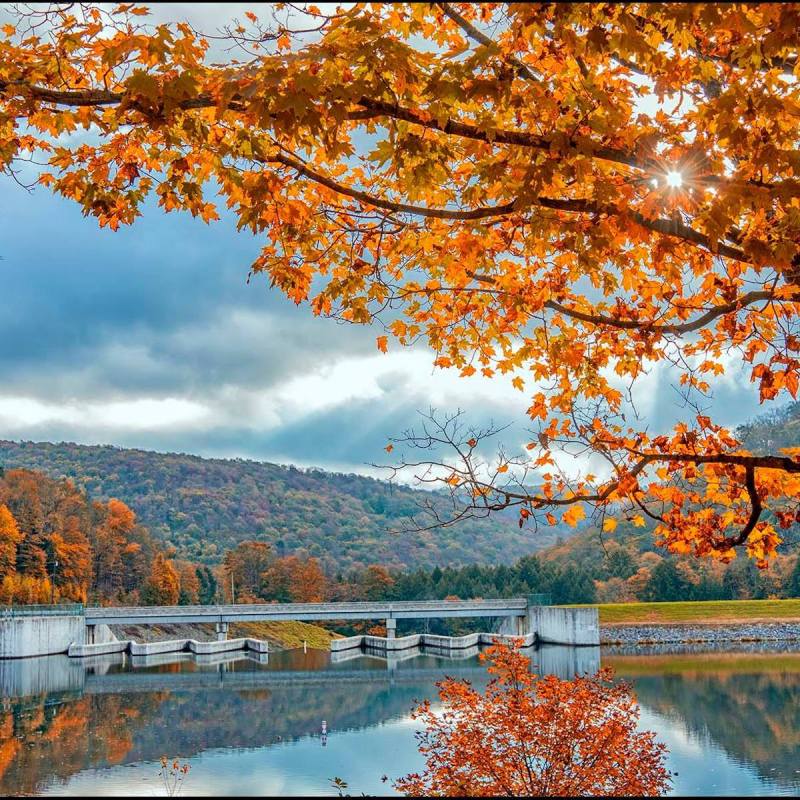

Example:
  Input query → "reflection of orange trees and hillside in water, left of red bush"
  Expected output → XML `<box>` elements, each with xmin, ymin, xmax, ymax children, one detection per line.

<box><xmin>0</xmin><ymin>654</ymin><xmax>494</xmax><ymax>794</ymax></box>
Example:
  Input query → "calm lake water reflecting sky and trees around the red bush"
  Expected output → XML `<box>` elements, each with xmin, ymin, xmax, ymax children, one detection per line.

<box><xmin>0</xmin><ymin>647</ymin><xmax>800</xmax><ymax>796</ymax></box>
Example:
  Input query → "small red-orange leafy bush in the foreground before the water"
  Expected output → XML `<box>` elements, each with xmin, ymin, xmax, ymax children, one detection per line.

<box><xmin>396</xmin><ymin>645</ymin><xmax>670</xmax><ymax>797</ymax></box>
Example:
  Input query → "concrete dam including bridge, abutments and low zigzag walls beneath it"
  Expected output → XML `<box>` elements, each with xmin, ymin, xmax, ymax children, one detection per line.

<box><xmin>0</xmin><ymin>598</ymin><xmax>600</xmax><ymax>659</ymax></box>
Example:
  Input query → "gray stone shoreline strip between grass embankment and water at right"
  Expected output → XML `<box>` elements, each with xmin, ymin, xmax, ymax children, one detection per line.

<box><xmin>600</xmin><ymin>622</ymin><xmax>800</xmax><ymax>645</ymax></box>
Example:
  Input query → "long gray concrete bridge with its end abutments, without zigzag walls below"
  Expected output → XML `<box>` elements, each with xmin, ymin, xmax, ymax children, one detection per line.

<box><xmin>0</xmin><ymin>598</ymin><xmax>600</xmax><ymax>659</ymax></box>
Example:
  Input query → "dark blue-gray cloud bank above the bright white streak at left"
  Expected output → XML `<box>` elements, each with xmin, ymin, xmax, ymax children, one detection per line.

<box><xmin>0</xmin><ymin>182</ymin><xmax>374</xmax><ymax>400</ymax></box>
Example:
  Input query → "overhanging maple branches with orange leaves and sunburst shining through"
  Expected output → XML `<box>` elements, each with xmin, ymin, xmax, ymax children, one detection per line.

<box><xmin>0</xmin><ymin>3</ymin><xmax>800</xmax><ymax>566</ymax></box>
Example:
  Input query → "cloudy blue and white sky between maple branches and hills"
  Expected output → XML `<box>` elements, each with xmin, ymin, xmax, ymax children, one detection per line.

<box><xmin>0</xmin><ymin>4</ymin><xmax>759</xmax><ymax>474</ymax></box>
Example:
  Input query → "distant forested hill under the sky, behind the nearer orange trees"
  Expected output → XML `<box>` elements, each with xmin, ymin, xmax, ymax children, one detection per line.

<box><xmin>0</xmin><ymin>440</ymin><xmax>556</xmax><ymax>575</ymax></box>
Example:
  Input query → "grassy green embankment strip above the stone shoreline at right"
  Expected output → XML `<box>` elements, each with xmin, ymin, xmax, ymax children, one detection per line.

<box><xmin>598</xmin><ymin>599</ymin><xmax>800</xmax><ymax>625</ymax></box>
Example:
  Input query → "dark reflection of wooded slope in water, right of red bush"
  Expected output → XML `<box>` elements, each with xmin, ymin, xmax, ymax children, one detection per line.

<box><xmin>613</xmin><ymin>657</ymin><xmax>800</xmax><ymax>789</ymax></box>
